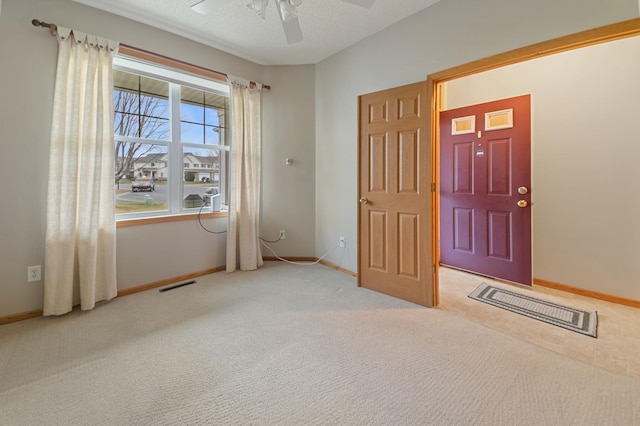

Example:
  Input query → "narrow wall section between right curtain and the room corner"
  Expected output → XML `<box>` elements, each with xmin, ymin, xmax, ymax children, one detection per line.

<box><xmin>262</xmin><ymin>65</ymin><xmax>315</xmax><ymax>256</ymax></box>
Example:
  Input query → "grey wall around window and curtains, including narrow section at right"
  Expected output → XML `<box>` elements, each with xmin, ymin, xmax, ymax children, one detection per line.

<box><xmin>0</xmin><ymin>0</ymin><xmax>315</xmax><ymax>317</ymax></box>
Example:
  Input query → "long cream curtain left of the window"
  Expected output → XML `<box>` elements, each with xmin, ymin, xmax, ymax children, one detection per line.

<box><xmin>44</xmin><ymin>27</ymin><xmax>118</xmax><ymax>315</ymax></box>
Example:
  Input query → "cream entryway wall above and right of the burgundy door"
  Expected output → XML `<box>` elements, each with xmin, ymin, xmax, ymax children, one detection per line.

<box><xmin>445</xmin><ymin>37</ymin><xmax>640</xmax><ymax>300</ymax></box>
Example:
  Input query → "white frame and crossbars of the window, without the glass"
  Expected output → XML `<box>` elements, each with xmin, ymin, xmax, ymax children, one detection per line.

<box><xmin>113</xmin><ymin>55</ymin><xmax>231</xmax><ymax>221</ymax></box>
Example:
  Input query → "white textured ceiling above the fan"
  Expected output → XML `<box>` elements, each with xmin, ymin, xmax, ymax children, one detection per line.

<box><xmin>74</xmin><ymin>0</ymin><xmax>439</xmax><ymax>65</ymax></box>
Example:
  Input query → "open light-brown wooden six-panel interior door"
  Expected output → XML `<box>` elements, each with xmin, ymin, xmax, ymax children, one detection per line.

<box><xmin>358</xmin><ymin>82</ymin><xmax>435</xmax><ymax>306</ymax></box>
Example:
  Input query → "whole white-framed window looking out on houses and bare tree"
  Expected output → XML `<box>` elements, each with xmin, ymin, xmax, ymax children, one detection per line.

<box><xmin>114</xmin><ymin>56</ymin><xmax>230</xmax><ymax>219</ymax></box>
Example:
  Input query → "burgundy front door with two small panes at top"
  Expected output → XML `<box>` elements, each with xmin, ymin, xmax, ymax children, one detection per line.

<box><xmin>440</xmin><ymin>95</ymin><xmax>532</xmax><ymax>285</ymax></box>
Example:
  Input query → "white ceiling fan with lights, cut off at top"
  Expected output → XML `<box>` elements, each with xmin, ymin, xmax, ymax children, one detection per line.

<box><xmin>191</xmin><ymin>0</ymin><xmax>376</xmax><ymax>44</ymax></box>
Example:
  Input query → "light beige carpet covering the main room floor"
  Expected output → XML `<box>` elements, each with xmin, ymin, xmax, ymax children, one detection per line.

<box><xmin>0</xmin><ymin>262</ymin><xmax>640</xmax><ymax>425</ymax></box>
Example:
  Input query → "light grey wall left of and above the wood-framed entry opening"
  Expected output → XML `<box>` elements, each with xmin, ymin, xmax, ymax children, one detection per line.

<box><xmin>316</xmin><ymin>0</ymin><xmax>638</xmax><ymax>278</ymax></box>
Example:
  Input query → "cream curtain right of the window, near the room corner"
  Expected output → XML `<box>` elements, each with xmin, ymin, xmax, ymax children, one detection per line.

<box><xmin>227</xmin><ymin>76</ymin><xmax>263</xmax><ymax>272</ymax></box>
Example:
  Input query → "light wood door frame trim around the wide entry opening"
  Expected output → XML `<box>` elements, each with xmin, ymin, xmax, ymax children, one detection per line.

<box><xmin>426</xmin><ymin>18</ymin><xmax>640</xmax><ymax>306</ymax></box>
